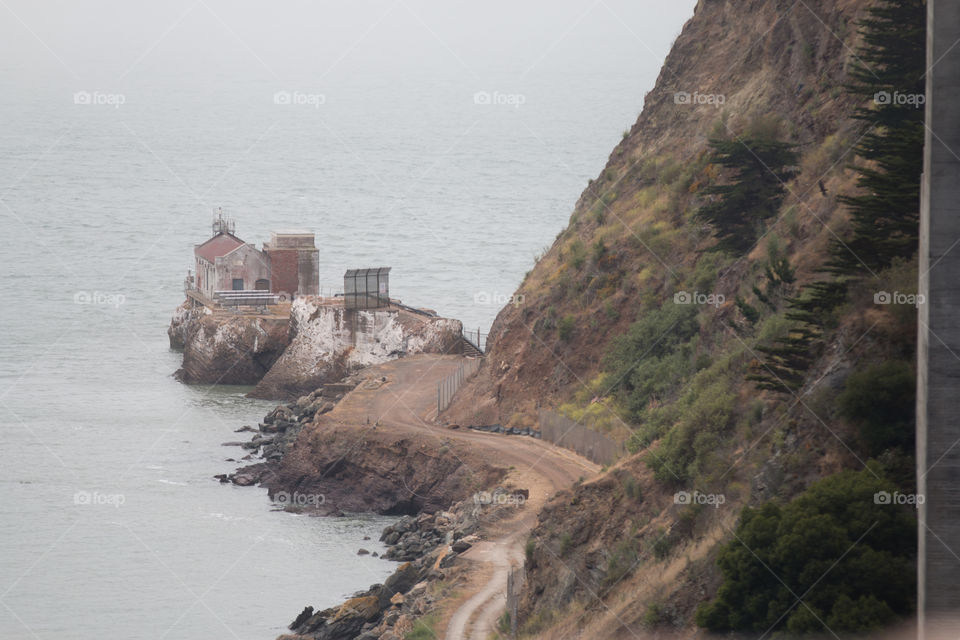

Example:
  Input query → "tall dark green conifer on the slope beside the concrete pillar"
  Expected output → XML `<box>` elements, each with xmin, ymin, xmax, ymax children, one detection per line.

<box><xmin>751</xmin><ymin>0</ymin><xmax>926</xmax><ymax>396</ymax></box>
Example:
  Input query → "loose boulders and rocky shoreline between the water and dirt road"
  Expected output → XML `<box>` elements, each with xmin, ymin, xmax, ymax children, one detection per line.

<box><xmin>215</xmin><ymin>372</ymin><xmax>528</xmax><ymax>640</ymax></box>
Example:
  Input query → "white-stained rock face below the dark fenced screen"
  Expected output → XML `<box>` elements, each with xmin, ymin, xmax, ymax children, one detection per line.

<box><xmin>250</xmin><ymin>298</ymin><xmax>461</xmax><ymax>399</ymax></box>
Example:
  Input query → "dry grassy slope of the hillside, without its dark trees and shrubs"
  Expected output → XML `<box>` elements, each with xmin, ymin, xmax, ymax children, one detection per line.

<box><xmin>451</xmin><ymin>0</ymin><xmax>915</xmax><ymax>637</ymax></box>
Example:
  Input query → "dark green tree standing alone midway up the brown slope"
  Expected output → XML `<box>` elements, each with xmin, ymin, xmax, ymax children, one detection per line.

<box><xmin>694</xmin><ymin>138</ymin><xmax>798</xmax><ymax>255</ymax></box>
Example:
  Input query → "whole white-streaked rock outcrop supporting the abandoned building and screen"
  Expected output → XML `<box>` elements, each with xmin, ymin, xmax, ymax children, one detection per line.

<box><xmin>167</xmin><ymin>298</ymin><xmax>462</xmax><ymax>400</ymax></box>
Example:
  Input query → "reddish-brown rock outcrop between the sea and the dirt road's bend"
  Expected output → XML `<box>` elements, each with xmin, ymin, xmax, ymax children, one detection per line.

<box><xmin>217</xmin><ymin>372</ymin><xmax>507</xmax><ymax>512</ymax></box>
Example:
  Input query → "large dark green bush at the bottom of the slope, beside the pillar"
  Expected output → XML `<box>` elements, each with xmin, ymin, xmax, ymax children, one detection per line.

<box><xmin>696</xmin><ymin>465</ymin><xmax>916</xmax><ymax>634</ymax></box>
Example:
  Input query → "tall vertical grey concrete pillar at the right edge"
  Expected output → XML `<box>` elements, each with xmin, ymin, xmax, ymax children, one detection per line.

<box><xmin>917</xmin><ymin>0</ymin><xmax>960</xmax><ymax>640</ymax></box>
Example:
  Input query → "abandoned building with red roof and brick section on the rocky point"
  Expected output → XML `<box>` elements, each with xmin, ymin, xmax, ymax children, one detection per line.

<box><xmin>186</xmin><ymin>211</ymin><xmax>320</xmax><ymax>301</ymax></box>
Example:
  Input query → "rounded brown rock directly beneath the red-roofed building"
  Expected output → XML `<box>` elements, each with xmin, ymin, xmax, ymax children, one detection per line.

<box><xmin>167</xmin><ymin>300</ymin><xmax>289</xmax><ymax>385</ymax></box>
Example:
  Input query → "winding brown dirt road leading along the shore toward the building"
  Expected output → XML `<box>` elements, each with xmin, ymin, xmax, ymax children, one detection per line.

<box><xmin>328</xmin><ymin>355</ymin><xmax>599</xmax><ymax>640</ymax></box>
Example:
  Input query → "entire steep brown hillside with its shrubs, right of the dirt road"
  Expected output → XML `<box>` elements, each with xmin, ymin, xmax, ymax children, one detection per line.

<box><xmin>447</xmin><ymin>0</ymin><xmax>916</xmax><ymax>638</ymax></box>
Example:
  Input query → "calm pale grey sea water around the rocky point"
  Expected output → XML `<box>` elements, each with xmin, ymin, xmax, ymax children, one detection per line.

<box><xmin>0</xmin><ymin>2</ymin><xmax>692</xmax><ymax>640</ymax></box>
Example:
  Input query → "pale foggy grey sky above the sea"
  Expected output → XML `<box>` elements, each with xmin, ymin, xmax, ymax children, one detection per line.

<box><xmin>0</xmin><ymin>0</ymin><xmax>695</xmax><ymax>89</ymax></box>
